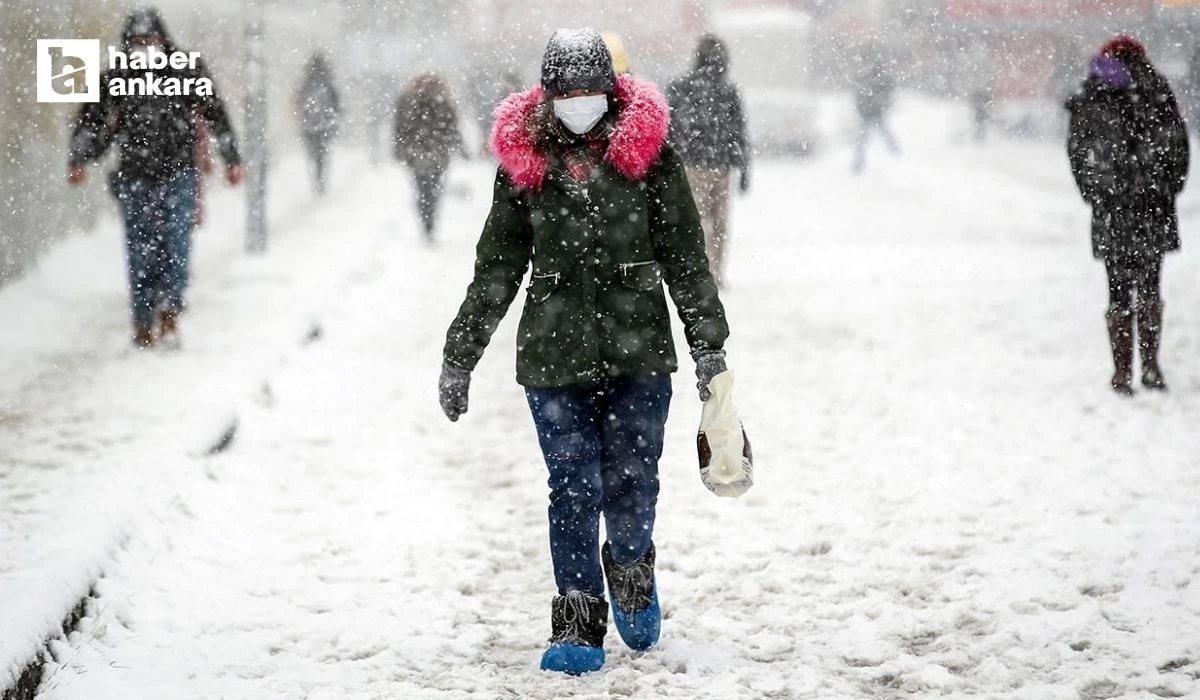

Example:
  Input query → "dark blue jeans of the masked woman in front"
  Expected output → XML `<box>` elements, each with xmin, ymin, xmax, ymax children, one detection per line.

<box><xmin>526</xmin><ymin>375</ymin><xmax>671</xmax><ymax>596</ymax></box>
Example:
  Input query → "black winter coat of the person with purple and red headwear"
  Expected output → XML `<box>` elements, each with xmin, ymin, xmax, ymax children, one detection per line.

<box><xmin>1067</xmin><ymin>59</ymin><xmax>1189</xmax><ymax>258</ymax></box>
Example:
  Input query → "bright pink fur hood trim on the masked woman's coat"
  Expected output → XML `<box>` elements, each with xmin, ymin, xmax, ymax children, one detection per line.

<box><xmin>491</xmin><ymin>76</ymin><xmax>671</xmax><ymax>190</ymax></box>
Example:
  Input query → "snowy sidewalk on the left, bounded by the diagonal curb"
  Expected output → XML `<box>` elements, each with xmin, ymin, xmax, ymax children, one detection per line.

<box><xmin>0</xmin><ymin>147</ymin><xmax>451</xmax><ymax>688</ymax></box>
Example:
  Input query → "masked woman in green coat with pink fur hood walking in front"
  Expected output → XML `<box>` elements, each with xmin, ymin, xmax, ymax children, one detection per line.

<box><xmin>439</xmin><ymin>30</ymin><xmax>728</xmax><ymax>674</ymax></box>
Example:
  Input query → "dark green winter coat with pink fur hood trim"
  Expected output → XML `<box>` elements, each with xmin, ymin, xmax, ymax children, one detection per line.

<box><xmin>444</xmin><ymin>76</ymin><xmax>728</xmax><ymax>388</ymax></box>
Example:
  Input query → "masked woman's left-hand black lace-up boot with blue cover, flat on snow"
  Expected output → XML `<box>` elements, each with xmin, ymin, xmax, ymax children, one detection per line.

<box><xmin>541</xmin><ymin>591</ymin><xmax>608</xmax><ymax>676</ymax></box>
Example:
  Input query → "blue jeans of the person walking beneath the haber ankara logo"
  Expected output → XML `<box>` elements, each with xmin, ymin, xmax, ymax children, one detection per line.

<box><xmin>115</xmin><ymin>169</ymin><xmax>199</xmax><ymax>324</ymax></box>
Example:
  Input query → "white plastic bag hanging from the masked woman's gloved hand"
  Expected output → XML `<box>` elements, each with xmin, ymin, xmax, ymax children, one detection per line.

<box><xmin>696</xmin><ymin>371</ymin><xmax>754</xmax><ymax>498</ymax></box>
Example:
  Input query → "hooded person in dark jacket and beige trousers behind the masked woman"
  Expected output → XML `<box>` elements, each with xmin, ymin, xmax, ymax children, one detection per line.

<box><xmin>667</xmin><ymin>34</ymin><xmax>750</xmax><ymax>286</ymax></box>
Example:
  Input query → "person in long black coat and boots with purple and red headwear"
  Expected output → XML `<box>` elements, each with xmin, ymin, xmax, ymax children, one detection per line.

<box><xmin>1067</xmin><ymin>36</ymin><xmax>1189</xmax><ymax>395</ymax></box>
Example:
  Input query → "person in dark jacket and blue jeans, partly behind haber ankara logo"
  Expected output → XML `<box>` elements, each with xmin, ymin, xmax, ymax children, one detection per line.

<box><xmin>67</xmin><ymin>10</ymin><xmax>242</xmax><ymax>348</ymax></box>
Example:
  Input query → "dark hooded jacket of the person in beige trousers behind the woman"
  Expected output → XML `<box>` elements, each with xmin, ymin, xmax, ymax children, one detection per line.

<box><xmin>667</xmin><ymin>37</ymin><xmax>750</xmax><ymax>169</ymax></box>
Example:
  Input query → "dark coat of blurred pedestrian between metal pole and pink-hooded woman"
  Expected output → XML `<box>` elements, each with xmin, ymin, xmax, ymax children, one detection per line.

<box><xmin>392</xmin><ymin>74</ymin><xmax>462</xmax><ymax>172</ymax></box>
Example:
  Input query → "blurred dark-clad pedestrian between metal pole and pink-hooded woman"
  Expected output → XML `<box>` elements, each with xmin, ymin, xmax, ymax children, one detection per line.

<box><xmin>392</xmin><ymin>73</ymin><xmax>466</xmax><ymax>241</ymax></box>
